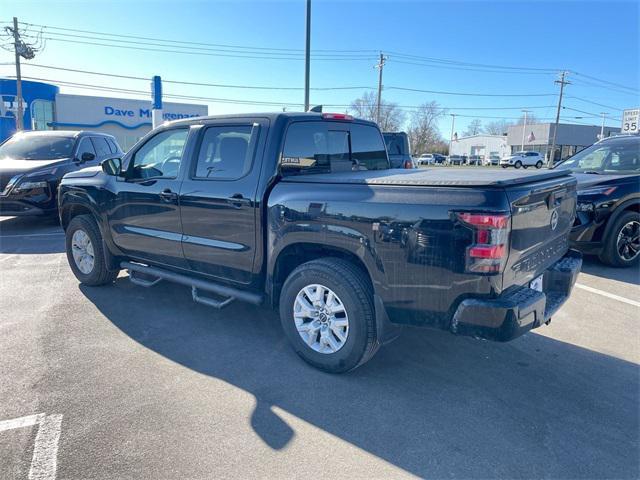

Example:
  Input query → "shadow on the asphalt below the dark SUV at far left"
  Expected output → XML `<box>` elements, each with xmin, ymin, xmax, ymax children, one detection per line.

<box><xmin>0</xmin><ymin>217</ymin><xmax>65</xmax><ymax>254</ymax></box>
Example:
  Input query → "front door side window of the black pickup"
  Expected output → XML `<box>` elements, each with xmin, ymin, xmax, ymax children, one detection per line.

<box><xmin>129</xmin><ymin>128</ymin><xmax>189</xmax><ymax>179</ymax></box>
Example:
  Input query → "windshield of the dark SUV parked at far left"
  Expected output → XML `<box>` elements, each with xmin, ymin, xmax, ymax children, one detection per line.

<box><xmin>0</xmin><ymin>135</ymin><xmax>75</xmax><ymax>160</ymax></box>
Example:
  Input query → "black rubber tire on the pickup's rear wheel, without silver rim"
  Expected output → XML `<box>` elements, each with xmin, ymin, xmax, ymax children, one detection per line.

<box><xmin>280</xmin><ymin>258</ymin><xmax>380</xmax><ymax>373</ymax></box>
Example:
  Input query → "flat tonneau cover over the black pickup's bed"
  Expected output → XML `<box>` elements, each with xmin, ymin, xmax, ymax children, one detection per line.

<box><xmin>282</xmin><ymin>167</ymin><xmax>571</xmax><ymax>187</ymax></box>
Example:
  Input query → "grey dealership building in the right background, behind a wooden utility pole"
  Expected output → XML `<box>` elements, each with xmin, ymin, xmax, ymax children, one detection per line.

<box><xmin>507</xmin><ymin>123</ymin><xmax>620</xmax><ymax>162</ymax></box>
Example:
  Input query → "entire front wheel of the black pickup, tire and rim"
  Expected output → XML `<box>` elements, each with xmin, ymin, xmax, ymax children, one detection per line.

<box><xmin>65</xmin><ymin>215</ymin><xmax>118</xmax><ymax>286</ymax></box>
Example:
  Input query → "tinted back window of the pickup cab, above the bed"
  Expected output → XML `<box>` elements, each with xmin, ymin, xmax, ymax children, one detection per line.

<box><xmin>280</xmin><ymin>122</ymin><xmax>389</xmax><ymax>175</ymax></box>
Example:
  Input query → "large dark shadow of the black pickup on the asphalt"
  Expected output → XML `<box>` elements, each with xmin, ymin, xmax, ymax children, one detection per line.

<box><xmin>80</xmin><ymin>277</ymin><xmax>640</xmax><ymax>478</ymax></box>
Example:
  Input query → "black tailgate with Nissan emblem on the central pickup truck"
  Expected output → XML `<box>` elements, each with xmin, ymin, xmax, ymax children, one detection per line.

<box><xmin>503</xmin><ymin>172</ymin><xmax>576</xmax><ymax>288</ymax></box>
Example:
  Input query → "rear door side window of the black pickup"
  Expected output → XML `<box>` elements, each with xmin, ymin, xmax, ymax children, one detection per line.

<box><xmin>194</xmin><ymin>125</ymin><xmax>259</xmax><ymax>180</ymax></box>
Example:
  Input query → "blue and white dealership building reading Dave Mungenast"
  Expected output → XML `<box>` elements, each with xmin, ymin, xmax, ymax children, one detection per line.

<box><xmin>0</xmin><ymin>78</ymin><xmax>208</xmax><ymax>151</ymax></box>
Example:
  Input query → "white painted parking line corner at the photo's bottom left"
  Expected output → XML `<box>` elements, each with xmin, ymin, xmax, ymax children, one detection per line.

<box><xmin>0</xmin><ymin>413</ymin><xmax>62</xmax><ymax>480</ymax></box>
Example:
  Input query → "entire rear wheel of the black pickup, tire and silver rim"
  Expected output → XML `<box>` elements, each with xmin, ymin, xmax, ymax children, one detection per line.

<box><xmin>280</xmin><ymin>258</ymin><xmax>379</xmax><ymax>373</ymax></box>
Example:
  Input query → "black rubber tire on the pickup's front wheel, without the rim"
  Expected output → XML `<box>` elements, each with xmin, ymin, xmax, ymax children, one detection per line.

<box><xmin>65</xmin><ymin>215</ymin><xmax>119</xmax><ymax>286</ymax></box>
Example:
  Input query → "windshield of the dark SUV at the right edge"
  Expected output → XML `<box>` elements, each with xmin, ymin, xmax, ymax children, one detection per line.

<box><xmin>556</xmin><ymin>137</ymin><xmax>640</xmax><ymax>174</ymax></box>
